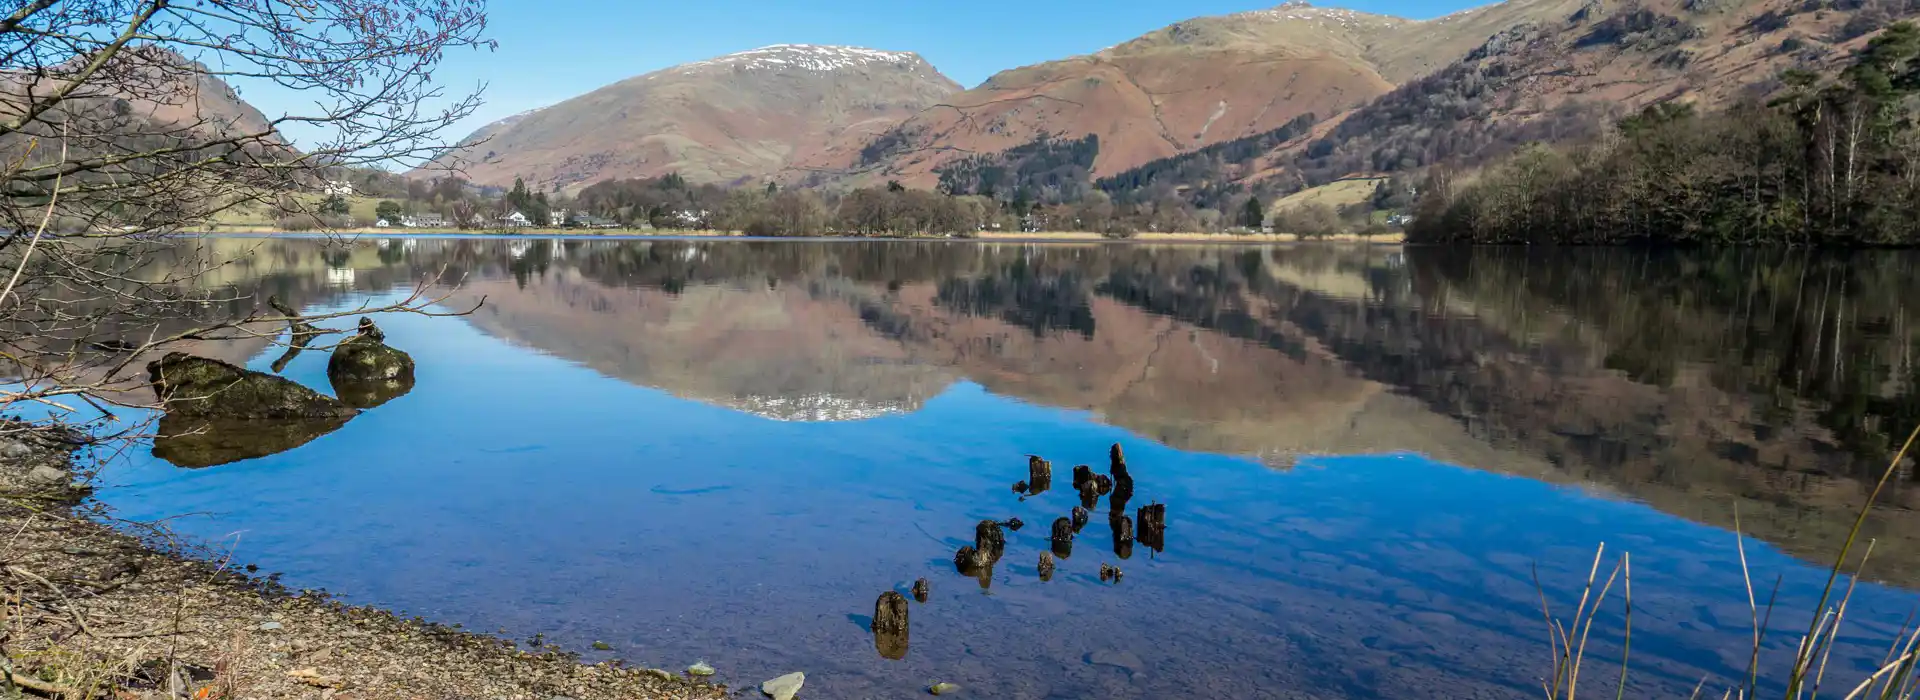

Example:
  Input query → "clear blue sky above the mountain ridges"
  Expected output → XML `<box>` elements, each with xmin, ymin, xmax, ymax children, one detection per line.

<box><xmin>242</xmin><ymin>0</ymin><xmax>1488</xmax><ymax>152</ymax></box>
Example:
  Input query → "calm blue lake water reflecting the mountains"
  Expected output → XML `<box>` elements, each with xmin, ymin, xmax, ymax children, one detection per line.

<box><xmin>100</xmin><ymin>238</ymin><xmax>1920</xmax><ymax>698</ymax></box>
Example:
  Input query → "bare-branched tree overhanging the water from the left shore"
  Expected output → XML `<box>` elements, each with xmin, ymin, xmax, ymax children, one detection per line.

<box><xmin>0</xmin><ymin>0</ymin><xmax>490</xmax><ymax>450</ymax></box>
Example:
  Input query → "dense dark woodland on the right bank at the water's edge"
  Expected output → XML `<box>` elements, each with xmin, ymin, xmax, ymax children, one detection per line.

<box><xmin>1407</xmin><ymin>21</ymin><xmax>1920</xmax><ymax>245</ymax></box>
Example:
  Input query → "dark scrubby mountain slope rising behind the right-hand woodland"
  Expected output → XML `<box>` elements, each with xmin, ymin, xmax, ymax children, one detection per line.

<box><xmin>1175</xmin><ymin>0</ymin><xmax>1916</xmax><ymax>188</ymax></box>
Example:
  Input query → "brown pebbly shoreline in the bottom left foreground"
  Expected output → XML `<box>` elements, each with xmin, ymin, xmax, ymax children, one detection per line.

<box><xmin>0</xmin><ymin>422</ymin><xmax>728</xmax><ymax>700</ymax></box>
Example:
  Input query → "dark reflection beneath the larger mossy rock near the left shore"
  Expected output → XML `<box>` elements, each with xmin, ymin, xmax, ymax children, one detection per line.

<box><xmin>154</xmin><ymin>412</ymin><xmax>348</xmax><ymax>470</ymax></box>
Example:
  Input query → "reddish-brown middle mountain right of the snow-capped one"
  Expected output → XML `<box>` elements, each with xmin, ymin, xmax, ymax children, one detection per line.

<box><xmin>847</xmin><ymin>0</ymin><xmax>1605</xmax><ymax>186</ymax></box>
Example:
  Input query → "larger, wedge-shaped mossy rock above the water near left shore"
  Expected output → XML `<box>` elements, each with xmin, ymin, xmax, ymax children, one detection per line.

<box><xmin>146</xmin><ymin>353</ymin><xmax>359</xmax><ymax>420</ymax></box>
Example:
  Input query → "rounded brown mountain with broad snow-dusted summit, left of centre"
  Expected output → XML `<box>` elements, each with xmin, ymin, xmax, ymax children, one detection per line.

<box><xmin>420</xmin><ymin>44</ymin><xmax>960</xmax><ymax>188</ymax></box>
